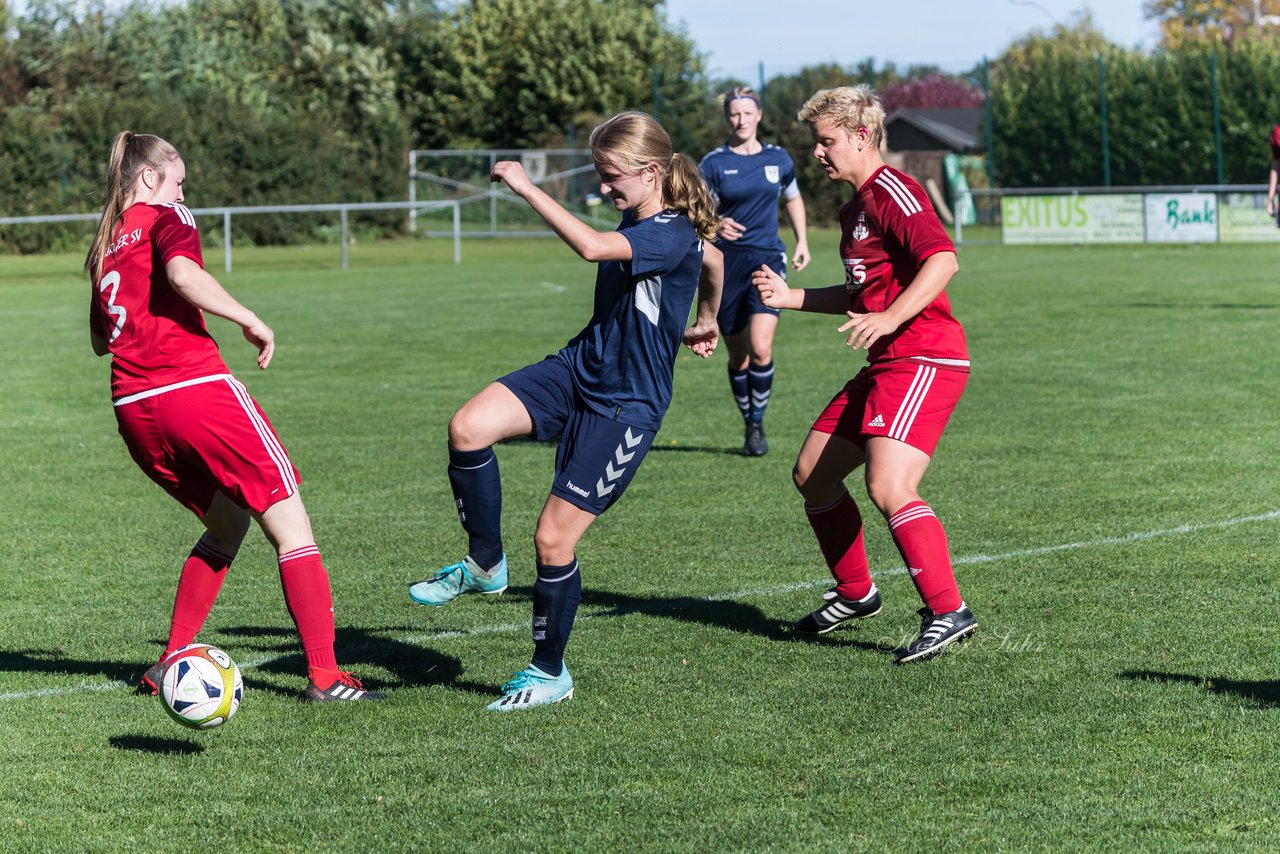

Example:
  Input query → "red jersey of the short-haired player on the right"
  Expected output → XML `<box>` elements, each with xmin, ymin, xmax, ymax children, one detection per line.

<box><xmin>840</xmin><ymin>166</ymin><xmax>969</xmax><ymax>370</ymax></box>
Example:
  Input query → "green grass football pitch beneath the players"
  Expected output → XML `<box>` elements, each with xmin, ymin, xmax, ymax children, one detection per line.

<box><xmin>0</xmin><ymin>233</ymin><xmax>1280</xmax><ymax>851</ymax></box>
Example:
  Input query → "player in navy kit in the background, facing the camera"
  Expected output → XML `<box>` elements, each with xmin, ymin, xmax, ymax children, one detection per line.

<box><xmin>698</xmin><ymin>86</ymin><xmax>809</xmax><ymax>457</ymax></box>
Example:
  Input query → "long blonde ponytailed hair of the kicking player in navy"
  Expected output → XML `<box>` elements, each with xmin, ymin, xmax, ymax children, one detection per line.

<box><xmin>591</xmin><ymin>111</ymin><xmax>719</xmax><ymax>241</ymax></box>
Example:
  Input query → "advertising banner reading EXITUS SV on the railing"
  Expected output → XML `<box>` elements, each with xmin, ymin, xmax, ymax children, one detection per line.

<box><xmin>1000</xmin><ymin>193</ymin><xmax>1144</xmax><ymax>243</ymax></box>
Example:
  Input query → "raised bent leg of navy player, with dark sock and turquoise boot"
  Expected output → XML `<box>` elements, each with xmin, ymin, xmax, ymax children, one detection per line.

<box><xmin>408</xmin><ymin>383</ymin><xmax>534</xmax><ymax>606</ymax></box>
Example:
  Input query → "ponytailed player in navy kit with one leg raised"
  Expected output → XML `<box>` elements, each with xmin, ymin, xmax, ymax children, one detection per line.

<box><xmin>410</xmin><ymin>113</ymin><xmax>723</xmax><ymax>712</ymax></box>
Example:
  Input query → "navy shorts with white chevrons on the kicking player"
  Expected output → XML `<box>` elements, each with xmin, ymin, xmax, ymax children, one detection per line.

<box><xmin>498</xmin><ymin>356</ymin><xmax>654</xmax><ymax>516</ymax></box>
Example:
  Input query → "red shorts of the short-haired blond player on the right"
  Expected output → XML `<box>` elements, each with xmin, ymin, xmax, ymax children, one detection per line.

<box><xmin>813</xmin><ymin>359</ymin><xmax>969</xmax><ymax>457</ymax></box>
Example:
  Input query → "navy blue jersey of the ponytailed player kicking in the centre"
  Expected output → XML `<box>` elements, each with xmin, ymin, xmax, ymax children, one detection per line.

<box><xmin>561</xmin><ymin>210</ymin><xmax>703</xmax><ymax>430</ymax></box>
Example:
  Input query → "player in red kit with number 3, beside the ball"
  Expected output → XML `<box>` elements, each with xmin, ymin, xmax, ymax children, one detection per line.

<box><xmin>84</xmin><ymin>131</ymin><xmax>384</xmax><ymax>703</ymax></box>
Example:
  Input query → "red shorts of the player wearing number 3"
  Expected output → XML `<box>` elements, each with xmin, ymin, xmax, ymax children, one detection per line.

<box><xmin>115</xmin><ymin>374</ymin><xmax>302</xmax><ymax>516</ymax></box>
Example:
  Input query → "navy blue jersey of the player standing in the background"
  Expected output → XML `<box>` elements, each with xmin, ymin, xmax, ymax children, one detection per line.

<box><xmin>698</xmin><ymin>143</ymin><xmax>800</xmax><ymax>252</ymax></box>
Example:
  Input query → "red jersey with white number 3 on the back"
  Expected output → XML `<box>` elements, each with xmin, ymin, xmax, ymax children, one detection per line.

<box><xmin>91</xmin><ymin>204</ymin><xmax>229</xmax><ymax>398</ymax></box>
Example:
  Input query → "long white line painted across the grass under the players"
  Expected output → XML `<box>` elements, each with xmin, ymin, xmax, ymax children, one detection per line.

<box><xmin>0</xmin><ymin>510</ymin><xmax>1280</xmax><ymax>702</ymax></box>
